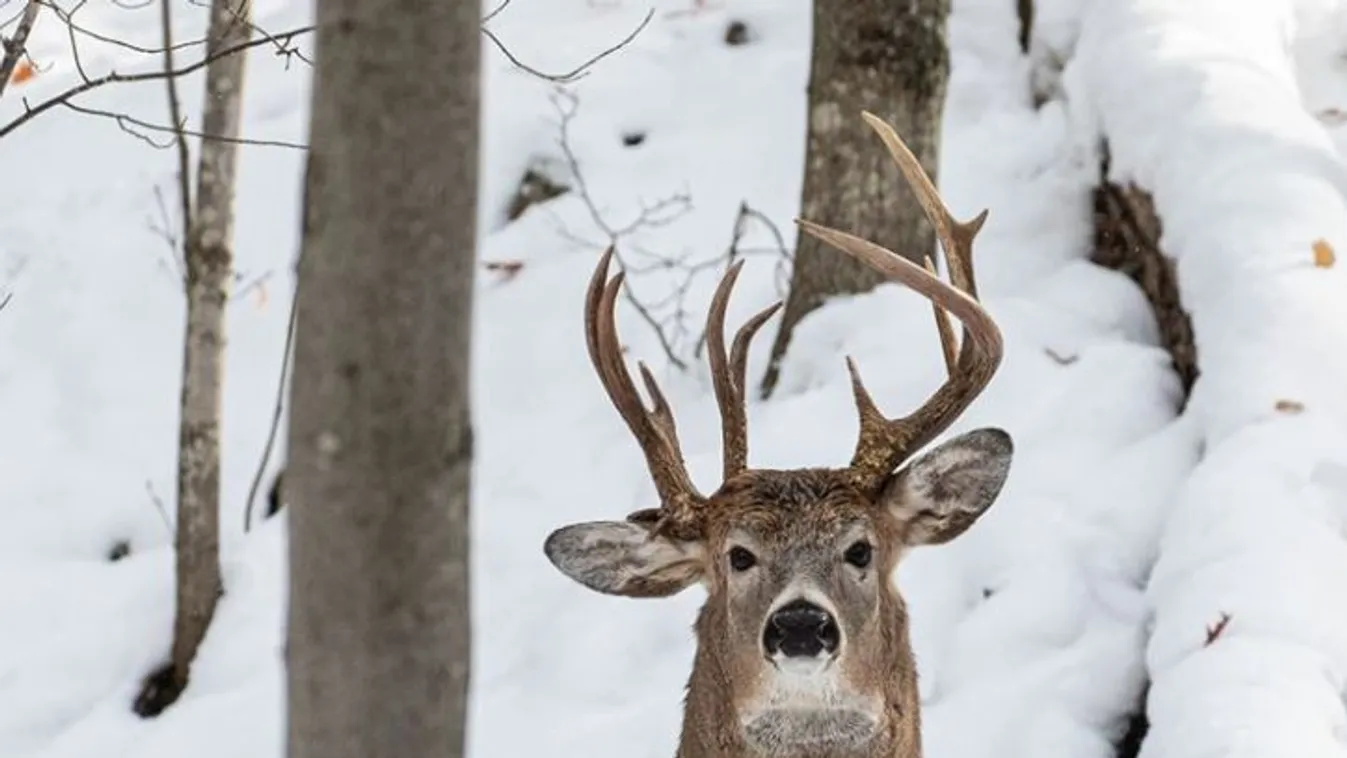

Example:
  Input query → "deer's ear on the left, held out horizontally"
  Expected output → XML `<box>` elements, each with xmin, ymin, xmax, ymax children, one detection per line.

<box><xmin>543</xmin><ymin>521</ymin><xmax>706</xmax><ymax>598</ymax></box>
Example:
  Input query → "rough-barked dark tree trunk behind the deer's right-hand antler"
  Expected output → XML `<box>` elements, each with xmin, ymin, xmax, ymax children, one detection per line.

<box><xmin>762</xmin><ymin>0</ymin><xmax>950</xmax><ymax>397</ymax></box>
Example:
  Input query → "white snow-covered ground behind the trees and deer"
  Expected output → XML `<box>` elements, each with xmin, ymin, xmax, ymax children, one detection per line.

<box><xmin>0</xmin><ymin>0</ymin><xmax>1347</xmax><ymax>758</ymax></box>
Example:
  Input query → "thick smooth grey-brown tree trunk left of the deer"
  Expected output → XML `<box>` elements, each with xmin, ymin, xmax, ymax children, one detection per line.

<box><xmin>286</xmin><ymin>0</ymin><xmax>480</xmax><ymax>758</ymax></box>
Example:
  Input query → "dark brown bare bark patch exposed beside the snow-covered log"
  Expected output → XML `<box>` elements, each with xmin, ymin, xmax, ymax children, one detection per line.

<box><xmin>1091</xmin><ymin>146</ymin><xmax>1197</xmax><ymax>399</ymax></box>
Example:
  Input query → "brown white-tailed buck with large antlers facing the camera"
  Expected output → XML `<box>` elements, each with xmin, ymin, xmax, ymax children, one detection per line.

<box><xmin>544</xmin><ymin>113</ymin><xmax>1012</xmax><ymax>758</ymax></box>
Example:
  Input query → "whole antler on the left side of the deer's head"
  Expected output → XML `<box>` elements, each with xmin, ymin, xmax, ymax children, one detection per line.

<box><xmin>585</xmin><ymin>246</ymin><xmax>781</xmax><ymax>537</ymax></box>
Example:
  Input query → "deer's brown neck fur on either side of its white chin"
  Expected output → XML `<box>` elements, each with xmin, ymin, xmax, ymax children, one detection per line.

<box><xmin>675</xmin><ymin>600</ymin><xmax>921</xmax><ymax>758</ymax></box>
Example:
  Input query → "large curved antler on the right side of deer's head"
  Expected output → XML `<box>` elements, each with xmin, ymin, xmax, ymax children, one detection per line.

<box><xmin>796</xmin><ymin>113</ymin><xmax>1002</xmax><ymax>494</ymax></box>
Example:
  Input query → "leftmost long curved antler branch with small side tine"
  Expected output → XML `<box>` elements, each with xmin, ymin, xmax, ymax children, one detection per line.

<box><xmin>585</xmin><ymin>246</ymin><xmax>703</xmax><ymax>522</ymax></box>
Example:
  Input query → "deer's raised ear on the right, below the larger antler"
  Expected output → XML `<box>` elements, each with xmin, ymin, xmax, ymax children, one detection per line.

<box><xmin>880</xmin><ymin>428</ymin><xmax>1014</xmax><ymax>547</ymax></box>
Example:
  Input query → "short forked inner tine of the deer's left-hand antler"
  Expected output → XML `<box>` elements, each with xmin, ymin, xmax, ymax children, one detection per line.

<box><xmin>706</xmin><ymin>260</ymin><xmax>781</xmax><ymax>479</ymax></box>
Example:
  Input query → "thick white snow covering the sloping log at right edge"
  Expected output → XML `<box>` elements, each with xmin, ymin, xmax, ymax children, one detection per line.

<box><xmin>1067</xmin><ymin>0</ymin><xmax>1347</xmax><ymax>758</ymax></box>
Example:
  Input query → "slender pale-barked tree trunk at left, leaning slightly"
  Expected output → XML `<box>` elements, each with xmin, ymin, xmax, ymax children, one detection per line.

<box><xmin>172</xmin><ymin>0</ymin><xmax>252</xmax><ymax>689</ymax></box>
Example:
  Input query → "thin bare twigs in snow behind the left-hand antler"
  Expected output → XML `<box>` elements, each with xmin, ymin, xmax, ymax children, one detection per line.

<box><xmin>552</xmin><ymin>88</ymin><xmax>791</xmax><ymax>370</ymax></box>
